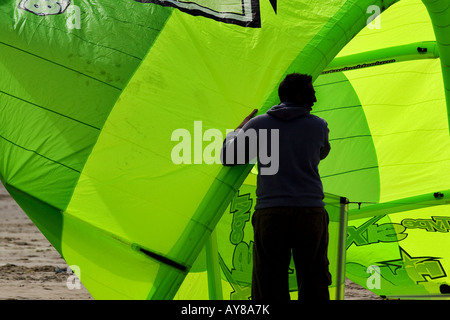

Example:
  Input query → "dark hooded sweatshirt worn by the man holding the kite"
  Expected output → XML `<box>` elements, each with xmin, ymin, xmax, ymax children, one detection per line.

<box><xmin>222</xmin><ymin>102</ymin><xmax>330</xmax><ymax>209</ymax></box>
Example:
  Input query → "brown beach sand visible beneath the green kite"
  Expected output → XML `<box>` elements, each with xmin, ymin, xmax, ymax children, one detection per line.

<box><xmin>0</xmin><ymin>183</ymin><xmax>380</xmax><ymax>300</ymax></box>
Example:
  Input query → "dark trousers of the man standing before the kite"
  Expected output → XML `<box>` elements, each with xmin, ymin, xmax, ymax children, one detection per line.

<box><xmin>252</xmin><ymin>207</ymin><xmax>331</xmax><ymax>300</ymax></box>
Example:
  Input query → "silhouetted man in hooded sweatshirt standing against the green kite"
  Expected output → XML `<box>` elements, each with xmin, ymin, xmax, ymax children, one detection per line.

<box><xmin>222</xmin><ymin>73</ymin><xmax>331</xmax><ymax>300</ymax></box>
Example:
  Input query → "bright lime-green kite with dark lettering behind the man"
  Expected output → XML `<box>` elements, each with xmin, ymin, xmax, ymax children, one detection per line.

<box><xmin>0</xmin><ymin>0</ymin><xmax>450</xmax><ymax>299</ymax></box>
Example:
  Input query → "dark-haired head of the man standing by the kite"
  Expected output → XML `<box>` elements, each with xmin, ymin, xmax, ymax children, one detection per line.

<box><xmin>278</xmin><ymin>73</ymin><xmax>317</xmax><ymax>110</ymax></box>
